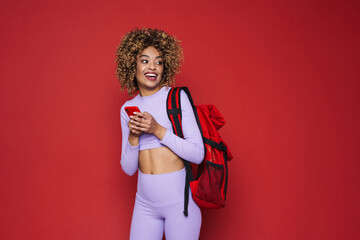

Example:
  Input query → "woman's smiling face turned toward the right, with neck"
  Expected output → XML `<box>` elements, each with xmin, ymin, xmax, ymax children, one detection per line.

<box><xmin>135</xmin><ymin>46</ymin><xmax>164</xmax><ymax>96</ymax></box>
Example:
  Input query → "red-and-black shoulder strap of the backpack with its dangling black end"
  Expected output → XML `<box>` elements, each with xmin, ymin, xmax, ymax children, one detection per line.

<box><xmin>166</xmin><ymin>87</ymin><xmax>195</xmax><ymax>216</ymax></box>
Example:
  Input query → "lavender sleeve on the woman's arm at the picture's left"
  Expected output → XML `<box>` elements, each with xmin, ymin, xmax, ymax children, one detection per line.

<box><xmin>120</xmin><ymin>106</ymin><xmax>139</xmax><ymax>176</ymax></box>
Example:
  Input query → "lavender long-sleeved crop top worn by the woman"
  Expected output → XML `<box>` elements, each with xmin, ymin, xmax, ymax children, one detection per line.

<box><xmin>120</xmin><ymin>87</ymin><xmax>204</xmax><ymax>175</ymax></box>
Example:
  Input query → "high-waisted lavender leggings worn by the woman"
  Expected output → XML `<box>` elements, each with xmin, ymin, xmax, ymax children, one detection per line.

<box><xmin>130</xmin><ymin>168</ymin><xmax>201</xmax><ymax>240</ymax></box>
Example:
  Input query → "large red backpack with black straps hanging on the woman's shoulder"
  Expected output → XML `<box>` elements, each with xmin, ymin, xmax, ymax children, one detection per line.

<box><xmin>167</xmin><ymin>87</ymin><xmax>232</xmax><ymax>216</ymax></box>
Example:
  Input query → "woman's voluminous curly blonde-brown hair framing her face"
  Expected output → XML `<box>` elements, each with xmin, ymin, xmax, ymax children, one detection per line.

<box><xmin>115</xmin><ymin>28</ymin><xmax>183</xmax><ymax>95</ymax></box>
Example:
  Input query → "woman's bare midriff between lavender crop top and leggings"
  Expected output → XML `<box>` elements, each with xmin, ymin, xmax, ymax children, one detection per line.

<box><xmin>139</xmin><ymin>147</ymin><xmax>184</xmax><ymax>174</ymax></box>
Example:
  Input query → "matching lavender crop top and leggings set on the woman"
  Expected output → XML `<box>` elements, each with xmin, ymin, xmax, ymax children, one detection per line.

<box><xmin>120</xmin><ymin>87</ymin><xmax>204</xmax><ymax>240</ymax></box>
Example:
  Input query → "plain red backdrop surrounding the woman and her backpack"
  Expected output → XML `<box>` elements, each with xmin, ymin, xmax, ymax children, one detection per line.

<box><xmin>0</xmin><ymin>0</ymin><xmax>360</xmax><ymax>240</ymax></box>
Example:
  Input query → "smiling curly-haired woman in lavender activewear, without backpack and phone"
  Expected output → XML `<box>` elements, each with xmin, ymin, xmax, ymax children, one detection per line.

<box><xmin>116</xmin><ymin>28</ymin><xmax>204</xmax><ymax>240</ymax></box>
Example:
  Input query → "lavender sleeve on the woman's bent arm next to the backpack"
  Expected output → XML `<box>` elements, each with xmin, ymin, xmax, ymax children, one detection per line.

<box><xmin>160</xmin><ymin>91</ymin><xmax>205</xmax><ymax>164</ymax></box>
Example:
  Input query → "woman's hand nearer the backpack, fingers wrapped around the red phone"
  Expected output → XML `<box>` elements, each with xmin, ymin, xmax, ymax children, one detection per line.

<box><xmin>130</xmin><ymin>112</ymin><xmax>167</xmax><ymax>140</ymax></box>
